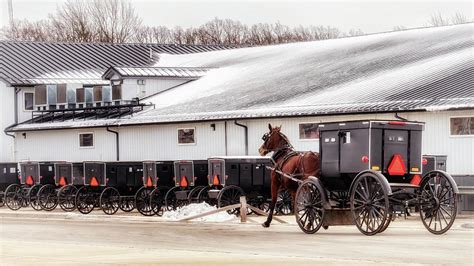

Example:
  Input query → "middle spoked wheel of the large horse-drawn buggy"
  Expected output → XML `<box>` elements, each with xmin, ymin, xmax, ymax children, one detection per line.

<box><xmin>351</xmin><ymin>173</ymin><xmax>390</xmax><ymax>236</ymax></box>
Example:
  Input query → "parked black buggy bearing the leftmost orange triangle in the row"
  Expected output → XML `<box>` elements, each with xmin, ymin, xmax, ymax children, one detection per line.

<box><xmin>5</xmin><ymin>162</ymin><xmax>54</xmax><ymax>211</ymax></box>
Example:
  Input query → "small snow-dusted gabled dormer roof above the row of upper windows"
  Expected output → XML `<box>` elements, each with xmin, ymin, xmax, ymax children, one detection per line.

<box><xmin>102</xmin><ymin>66</ymin><xmax>210</xmax><ymax>78</ymax></box>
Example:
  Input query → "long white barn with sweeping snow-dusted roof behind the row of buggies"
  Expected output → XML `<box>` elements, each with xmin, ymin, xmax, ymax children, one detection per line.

<box><xmin>0</xmin><ymin>24</ymin><xmax>474</xmax><ymax>207</ymax></box>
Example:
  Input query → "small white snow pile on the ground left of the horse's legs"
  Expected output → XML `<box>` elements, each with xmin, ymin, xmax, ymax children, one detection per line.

<box><xmin>163</xmin><ymin>202</ymin><xmax>236</xmax><ymax>222</ymax></box>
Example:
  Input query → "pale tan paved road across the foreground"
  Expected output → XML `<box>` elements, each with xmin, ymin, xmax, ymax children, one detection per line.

<box><xmin>0</xmin><ymin>209</ymin><xmax>474</xmax><ymax>265</ymax></box>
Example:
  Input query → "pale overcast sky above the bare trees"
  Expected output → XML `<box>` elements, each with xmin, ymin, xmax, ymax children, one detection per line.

<box><xmin>0</xmin><ymin>0</ymin><xmax>473</xmax><ymax>33</ymax></box>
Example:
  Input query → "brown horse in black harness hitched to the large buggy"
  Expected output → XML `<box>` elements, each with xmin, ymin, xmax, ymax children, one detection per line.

<box><xmin>258</xmin><ymin>124</ymin><xmax>320</xmax><ymax>227</ymax></box>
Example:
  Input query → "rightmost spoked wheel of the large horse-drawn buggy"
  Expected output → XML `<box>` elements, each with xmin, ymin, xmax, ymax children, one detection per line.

<box><xmin>419</xmin><ymin>171</ymin><xmax>457</xmax><ymax>235</ymax></box>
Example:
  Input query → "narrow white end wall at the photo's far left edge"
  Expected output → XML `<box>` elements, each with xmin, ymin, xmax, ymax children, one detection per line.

<box><xmin>0</xmin><ymin>80</ymin><xmax>15</xmax><ymax>162</ymax></box>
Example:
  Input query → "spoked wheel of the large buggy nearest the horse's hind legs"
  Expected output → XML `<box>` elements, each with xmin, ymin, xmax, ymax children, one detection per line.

<box><xmin>295</xmin><ymin>180</ymin><xmax>325</xmax><ymax>234</ymax></box>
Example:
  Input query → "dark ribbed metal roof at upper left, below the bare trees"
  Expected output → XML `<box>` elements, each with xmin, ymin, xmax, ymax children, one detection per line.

<box><xmin>0</xmin><ymin>41</ymin><xmax>233</xmax><ymax>85</ymax></box>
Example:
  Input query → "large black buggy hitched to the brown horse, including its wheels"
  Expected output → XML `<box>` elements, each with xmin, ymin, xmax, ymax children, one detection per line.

<box><xmin>295</xmin><ymin>121</ymin><xmax>458</xmax><ymax>235</ymax></box>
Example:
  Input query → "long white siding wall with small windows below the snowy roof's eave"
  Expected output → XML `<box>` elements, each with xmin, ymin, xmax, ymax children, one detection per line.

<box><xmin>12</xmin><ymin>110</ymin><xmax>474</xmax><ymax>175</ymax></box>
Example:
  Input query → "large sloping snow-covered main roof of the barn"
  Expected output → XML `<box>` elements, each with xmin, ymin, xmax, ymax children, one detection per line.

<box><xmin>9</xmin><ymin>23</ymin><xmax>474</xmax><ymax>130</ymax></box>
